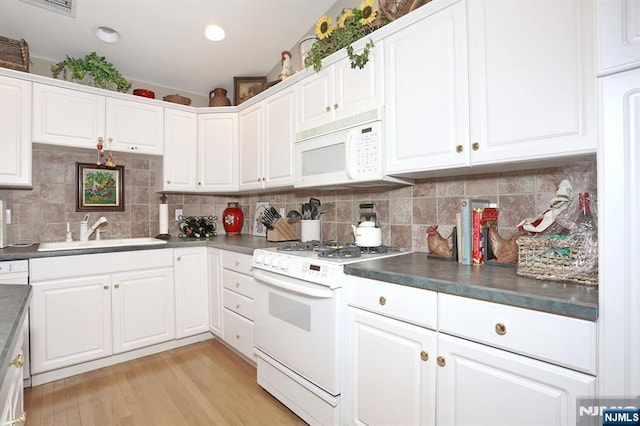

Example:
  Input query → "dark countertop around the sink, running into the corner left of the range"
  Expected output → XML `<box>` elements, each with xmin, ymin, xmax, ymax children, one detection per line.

<box><xmin>0</xmin><ymin>234</ymin><xmax>276</xmax><ymax>262</ymax></box>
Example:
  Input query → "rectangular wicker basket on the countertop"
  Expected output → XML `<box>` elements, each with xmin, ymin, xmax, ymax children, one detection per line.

<box><xmin>516</xmin><ymin>235</ymin><xmax>598</xmax><ymax>285</ymax></box>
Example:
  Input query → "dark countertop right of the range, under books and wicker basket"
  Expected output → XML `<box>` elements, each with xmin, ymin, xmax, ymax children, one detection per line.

<box><xmin>345</xmin><ymin>252</ymin><xmax>598</xmax><ymax>321</ymax></box>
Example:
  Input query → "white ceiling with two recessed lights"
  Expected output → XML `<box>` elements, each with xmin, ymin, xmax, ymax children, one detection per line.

<box><xmin>0</xmin><ymin>0</ymin><xmax>336</xmax><ymax>96</ymax></box>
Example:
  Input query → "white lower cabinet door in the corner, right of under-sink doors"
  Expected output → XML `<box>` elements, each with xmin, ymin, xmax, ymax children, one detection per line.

<box><xmin>173</xmin><ymin>247</ymin><xmax>209</xmax><ymax>339</ymax></box>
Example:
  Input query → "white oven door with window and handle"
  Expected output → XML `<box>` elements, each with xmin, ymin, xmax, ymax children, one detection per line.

<box><xmin>254</xmin><ymin>270</ymin><xmax>342</xmax><ymax>396</ymax></box>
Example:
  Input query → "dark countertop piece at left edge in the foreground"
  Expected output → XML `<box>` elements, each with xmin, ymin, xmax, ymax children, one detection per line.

<box><xmin>0</xmin><ymin>284</ymin><xmax>31</xmax><ymax>382</ymax></box>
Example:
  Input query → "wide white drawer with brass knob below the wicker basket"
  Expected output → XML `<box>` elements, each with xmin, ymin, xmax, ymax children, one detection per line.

<box><xmin>438</xmin><ymin>294</ymin><xmax>596</xmax><ymax>374</ymax></box>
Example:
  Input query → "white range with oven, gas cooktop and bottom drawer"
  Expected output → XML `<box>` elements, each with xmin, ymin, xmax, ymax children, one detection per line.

<box><xmin>252</xmin><ymin>241</ymin><xmax>410</xmax><ymax>425</ymax></box>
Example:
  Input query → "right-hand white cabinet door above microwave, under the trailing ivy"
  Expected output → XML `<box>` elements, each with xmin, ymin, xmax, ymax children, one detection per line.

<box><xmin>331</xmin><ymin>37</ymin><xmax>386</xmax><ymax>120</ymax></box>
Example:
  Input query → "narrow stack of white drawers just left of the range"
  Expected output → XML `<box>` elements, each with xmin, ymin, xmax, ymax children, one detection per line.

<box><xmin>222</xmin><ymin>250</ymin><xmax>255</xmax><ymax>362</ymax></box>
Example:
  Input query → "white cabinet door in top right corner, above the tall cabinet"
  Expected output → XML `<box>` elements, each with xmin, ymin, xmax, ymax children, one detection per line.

<box><xmin>596</xmin><ymin>0</ymin><xmax>640</xmax><ymax>75</ymax></box>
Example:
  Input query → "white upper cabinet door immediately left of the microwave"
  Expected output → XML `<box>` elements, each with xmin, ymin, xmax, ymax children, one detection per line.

<box><xmin>263</xmin><ymin>88</ymin><xmax>296</xmax><ymax>188</ymax></box>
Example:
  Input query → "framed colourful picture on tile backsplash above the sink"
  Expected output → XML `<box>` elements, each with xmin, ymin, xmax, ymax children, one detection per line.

<box><xmin>76</xmin><ymin>163</ymin><xmax>124</xmax><ymax>212</ymax></box>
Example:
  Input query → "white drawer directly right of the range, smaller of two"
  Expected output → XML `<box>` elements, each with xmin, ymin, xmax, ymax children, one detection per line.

<box><xmin>347</xmin><ymin>276</ymin><xmax>438</xmax><ymax>328</ymax></box>
